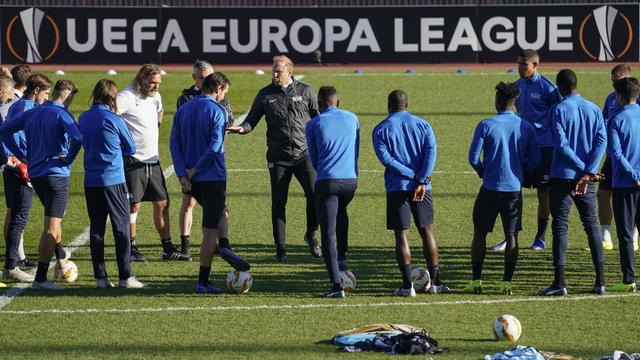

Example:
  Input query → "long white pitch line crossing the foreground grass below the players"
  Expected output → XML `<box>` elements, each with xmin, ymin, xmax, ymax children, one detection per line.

<box><xmin>2</xmin><ymin>293</ymin><xmax>640</xmax><ymax>315</ymax></box>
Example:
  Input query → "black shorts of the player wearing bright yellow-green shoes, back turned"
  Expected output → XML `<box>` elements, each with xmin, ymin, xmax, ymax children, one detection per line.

<box><xmin>473</xmin><ymin>187</ymin><xmax>522</xmax><ymax>233</ymax></box>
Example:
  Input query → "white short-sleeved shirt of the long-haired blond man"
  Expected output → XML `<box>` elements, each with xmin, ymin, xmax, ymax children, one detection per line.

<box><xmin>116</xmin><ymin>86</ymin><xmax>162</xmax><ymax>164</ymax></box>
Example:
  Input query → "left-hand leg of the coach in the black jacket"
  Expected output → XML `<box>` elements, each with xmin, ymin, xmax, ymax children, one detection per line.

<box><xmin>268</xmin><ymin>163</ymin><xmax>293</xmax><ymax>262</ymax></box>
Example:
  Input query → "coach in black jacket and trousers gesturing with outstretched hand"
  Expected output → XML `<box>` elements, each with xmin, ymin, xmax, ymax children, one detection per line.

<box><xmin>227</xmin><ymin>56</ymin><xmax>322</xmax><ymax>261</ymax></box>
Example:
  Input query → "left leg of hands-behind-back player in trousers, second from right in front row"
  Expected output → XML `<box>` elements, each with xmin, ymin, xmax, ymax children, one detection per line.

<box><xmin>538</xmin><ymin>180</ymin><xmax>575</xmax><ymax>296</ymax></box>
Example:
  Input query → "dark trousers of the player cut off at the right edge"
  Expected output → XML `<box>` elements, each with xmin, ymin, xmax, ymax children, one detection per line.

<box><xmin>613</xmin><ymin>188</ymin><xmax>640</xmax><ymax>284</ymax></box>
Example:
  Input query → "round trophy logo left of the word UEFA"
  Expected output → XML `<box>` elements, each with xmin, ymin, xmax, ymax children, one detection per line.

<box><xmin>7</xmin><ymin>8</ymin><xmax>60</xmax><ymax>63</ymax></box>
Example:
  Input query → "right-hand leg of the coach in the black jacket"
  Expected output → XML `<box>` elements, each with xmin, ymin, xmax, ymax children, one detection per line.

<box><xmin>293</xmin><ymin>157</ymin><xmax>322</xmax><ymax>258</ymax></box>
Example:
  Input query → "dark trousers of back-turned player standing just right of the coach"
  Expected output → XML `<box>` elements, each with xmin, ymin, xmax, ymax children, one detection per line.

<box><xmin>314</xmin><ymin>179</ymin><xmax>356</xmax><ymax>284</ymax></box>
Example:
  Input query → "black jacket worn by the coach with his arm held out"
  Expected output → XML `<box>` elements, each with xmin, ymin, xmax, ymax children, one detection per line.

<box><xmin>240</xmin><ymin>80</ymin><xmax>318</xmax><ymax>163</ymax></box>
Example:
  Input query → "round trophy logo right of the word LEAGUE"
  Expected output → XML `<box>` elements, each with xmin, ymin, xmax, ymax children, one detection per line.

<box><xmin>579</xmin><ymin>5</ymin><xmax>633</xmax><ymax>61</ymax></box>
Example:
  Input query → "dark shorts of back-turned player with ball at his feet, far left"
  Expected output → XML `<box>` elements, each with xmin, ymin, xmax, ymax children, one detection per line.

<box><xmin>31</xmin><ymin>176</ymin><xmax>71</xmax><ymax>219</ymax></box>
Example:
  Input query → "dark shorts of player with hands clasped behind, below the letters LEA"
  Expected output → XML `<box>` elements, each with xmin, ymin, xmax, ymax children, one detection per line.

<box><xmin>387</xmin><ymin>190</ymin><xmax>433</xmax><ymax>230</ymax></box>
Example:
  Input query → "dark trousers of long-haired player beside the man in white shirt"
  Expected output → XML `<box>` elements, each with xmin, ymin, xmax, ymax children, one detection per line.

<box><xmin>84</xmin><ymin>183</ymin><xmax>131</xmax><ymax>280</ymax></box>
